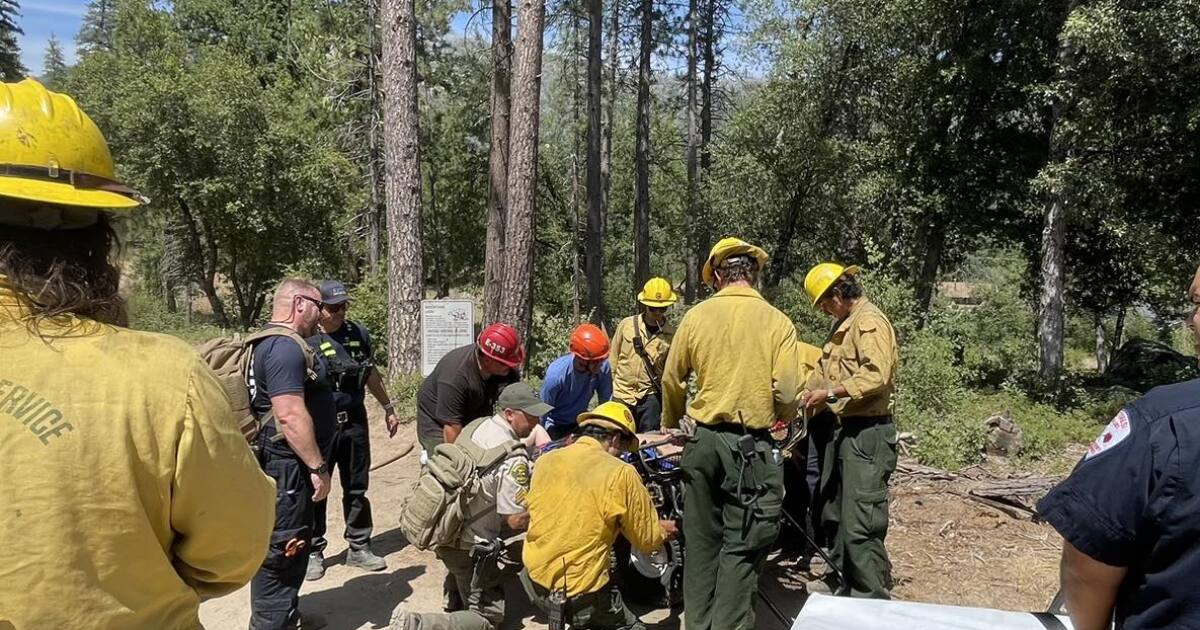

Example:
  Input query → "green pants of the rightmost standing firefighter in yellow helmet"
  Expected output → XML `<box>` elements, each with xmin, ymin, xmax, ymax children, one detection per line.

<box><xmin>825</xmin><ymin>416</ymin><xmax>896</xmax><ymax>599</ymax></box>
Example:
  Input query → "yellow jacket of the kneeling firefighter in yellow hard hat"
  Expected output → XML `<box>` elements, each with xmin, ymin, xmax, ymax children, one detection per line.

<box><xmin>523</xmin><ymin>438</ymin><xmax>666</xmax><ymax>596</ymax></box>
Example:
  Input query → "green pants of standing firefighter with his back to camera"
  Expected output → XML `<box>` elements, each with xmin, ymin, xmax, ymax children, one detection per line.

<box><xmin>682</xmin><ymin>425</ymin><xmax>784</xmax><ymax>630</ymax></box>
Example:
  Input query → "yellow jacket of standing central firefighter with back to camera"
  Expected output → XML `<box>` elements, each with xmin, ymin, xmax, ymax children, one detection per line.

<box><xmin>662</xmin><ymin>287</ymin><xmax>803</xmax><ymax>428</ymax></box>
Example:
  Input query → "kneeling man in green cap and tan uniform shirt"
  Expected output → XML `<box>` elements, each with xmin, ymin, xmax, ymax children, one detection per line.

<box><xmin>391</xmin><ymin>383</ymin><xmax>551</xmax><ymax>630</ymax></box>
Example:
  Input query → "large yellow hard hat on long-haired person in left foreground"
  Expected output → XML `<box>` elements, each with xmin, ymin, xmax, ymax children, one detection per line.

<box><xmin>0</xmin><ymin>79</ymin><xmax>145</xmax><ymax>210</ymax></box>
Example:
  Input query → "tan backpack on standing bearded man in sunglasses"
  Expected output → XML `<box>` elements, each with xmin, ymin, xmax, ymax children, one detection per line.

<box><xmin>197</xmin><ymin>326</ymin><xmax>316</xmax><ymax>444</ymax></box>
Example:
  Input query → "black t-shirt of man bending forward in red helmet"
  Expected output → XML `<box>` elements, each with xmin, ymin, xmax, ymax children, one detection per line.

<box><xmin>416</xmin><ymin>344</ymin><xmax>521</xmax><ymax>438</ymax></box>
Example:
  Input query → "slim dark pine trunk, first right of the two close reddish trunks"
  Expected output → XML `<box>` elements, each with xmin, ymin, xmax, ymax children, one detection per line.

<box><xmin>584</xmin><ymin>0</ymin><xmax>604</xmax><ymax>323</ymax></box>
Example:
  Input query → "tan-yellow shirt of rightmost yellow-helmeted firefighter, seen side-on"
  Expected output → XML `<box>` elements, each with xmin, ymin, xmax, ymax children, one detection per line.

<box><xmin>808</xmin><ymin>298</ymin><xmax>899</xmax><ymax>418</ymax></box>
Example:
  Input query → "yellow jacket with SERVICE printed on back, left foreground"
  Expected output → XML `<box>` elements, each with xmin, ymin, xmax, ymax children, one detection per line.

<box><xmin>0</xmin><ymin>276</ymin><xmax>275</xmax><ymax>630</ymax></box>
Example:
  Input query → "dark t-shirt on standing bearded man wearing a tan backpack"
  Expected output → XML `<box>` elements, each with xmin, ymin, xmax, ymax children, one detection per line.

<box><xmin>250</xmin><ymin>326</ymin><xmax>337</xmax><ymax>450</ymax></box>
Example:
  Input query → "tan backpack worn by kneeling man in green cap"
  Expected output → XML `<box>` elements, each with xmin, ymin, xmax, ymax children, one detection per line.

<box><xmin>400</xmin><ymin>418</ymin><xmax>527</xmax><ymax>551</ymax></box>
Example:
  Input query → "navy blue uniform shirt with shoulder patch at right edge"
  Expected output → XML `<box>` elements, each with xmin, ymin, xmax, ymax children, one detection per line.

<box><xmin>1038</xmin><ymin>380</ymin><xmax>1200</xmax><ymax>630</ymax></box>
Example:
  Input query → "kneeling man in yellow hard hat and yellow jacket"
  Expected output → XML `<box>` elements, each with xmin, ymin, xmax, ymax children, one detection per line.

<box><xmin>521</xmin><ymin>402</ymin><xmax>678</xmax><ymax>630</ymax></box>
